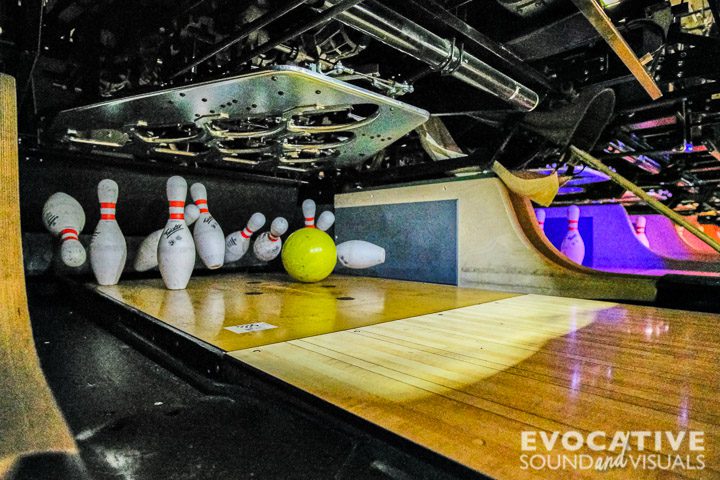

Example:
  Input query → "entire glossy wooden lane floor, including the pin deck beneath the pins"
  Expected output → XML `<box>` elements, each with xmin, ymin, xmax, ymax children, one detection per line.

<box><xmin>97</xmin><ymin>275</ymin><xmax>720</xmax><ymax>479</ymax></box>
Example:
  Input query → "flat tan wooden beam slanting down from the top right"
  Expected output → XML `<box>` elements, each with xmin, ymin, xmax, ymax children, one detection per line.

<box><xmin>572</xmin><ymin>0</ymin><xmax>662</xmax><ymax>100</ymax></box>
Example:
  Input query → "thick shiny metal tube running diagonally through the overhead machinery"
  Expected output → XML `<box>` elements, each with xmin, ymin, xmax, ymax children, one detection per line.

<box><xmin>325</xmin><ymin>0</ymin><xmax>540</xmax><ymax>111</ymax></box>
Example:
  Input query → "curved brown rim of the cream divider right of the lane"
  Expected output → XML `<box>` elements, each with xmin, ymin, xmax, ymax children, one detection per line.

<box><xmin>508</xmin><ymin>188</ymin><xmax>657</xmax><ymax>301</ymax></box>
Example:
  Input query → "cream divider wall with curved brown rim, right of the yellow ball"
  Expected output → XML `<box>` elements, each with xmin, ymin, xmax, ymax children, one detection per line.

<box><xmin>335</xmin><ymin>178</ymin><xmax>656</xmax><ymax>301</ymax></box>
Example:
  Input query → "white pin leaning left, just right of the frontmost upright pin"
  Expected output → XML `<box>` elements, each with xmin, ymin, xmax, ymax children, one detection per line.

<box><xmin>190</xmin><ymin>183</ymin><xmax>225</xmax><ymax>270</ymax></box>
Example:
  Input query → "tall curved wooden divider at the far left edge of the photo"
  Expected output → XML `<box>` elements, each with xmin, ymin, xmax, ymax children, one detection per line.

<box><xmin>0</xmin><ymin>74</ymin><xmax>77</xmax><ymax>472</ymax></box>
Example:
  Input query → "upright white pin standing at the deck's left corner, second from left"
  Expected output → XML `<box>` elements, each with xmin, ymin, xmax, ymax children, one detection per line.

<box><xmin>90</xmin><ymin>178</ymin><xmax>127</xmax><ymax>285</ymax></box>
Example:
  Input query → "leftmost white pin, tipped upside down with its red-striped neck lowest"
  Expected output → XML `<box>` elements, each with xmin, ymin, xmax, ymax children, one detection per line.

<box><xmin>42</xmin><ymin>192</ymin><xmax>87</xmax><ymax>267</ymax></box>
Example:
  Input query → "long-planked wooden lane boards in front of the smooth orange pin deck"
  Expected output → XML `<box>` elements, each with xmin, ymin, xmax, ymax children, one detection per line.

<box><xmin>230</xmin><ymin>295</ymin><xmax>720</xmax><ymax>479</ymax></box>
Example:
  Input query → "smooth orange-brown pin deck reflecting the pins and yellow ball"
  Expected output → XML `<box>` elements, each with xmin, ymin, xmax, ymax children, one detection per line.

<box><xmin>96</xmin><ymin>274</ymin><xmax>514</xmax><ymax>351</ymax></box>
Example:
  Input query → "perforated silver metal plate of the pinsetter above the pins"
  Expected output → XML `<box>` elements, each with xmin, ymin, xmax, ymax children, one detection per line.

<box><xmin>50</xmin><ymin>66</ymin><xmax>429</xmax><ymax>171</ymax></box>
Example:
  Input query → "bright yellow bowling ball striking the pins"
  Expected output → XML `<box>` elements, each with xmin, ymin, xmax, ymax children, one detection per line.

<box><xmin>282</xmin><ymin>228</ymin><xmax>337</xmax><ymax>282</ymax></box>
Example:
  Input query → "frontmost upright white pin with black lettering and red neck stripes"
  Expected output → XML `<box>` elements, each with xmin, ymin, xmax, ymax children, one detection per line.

<box><xmin>157</xmin><ymin>176</ymin><xmax>195</xmax><ymax>290</ymax></box>
